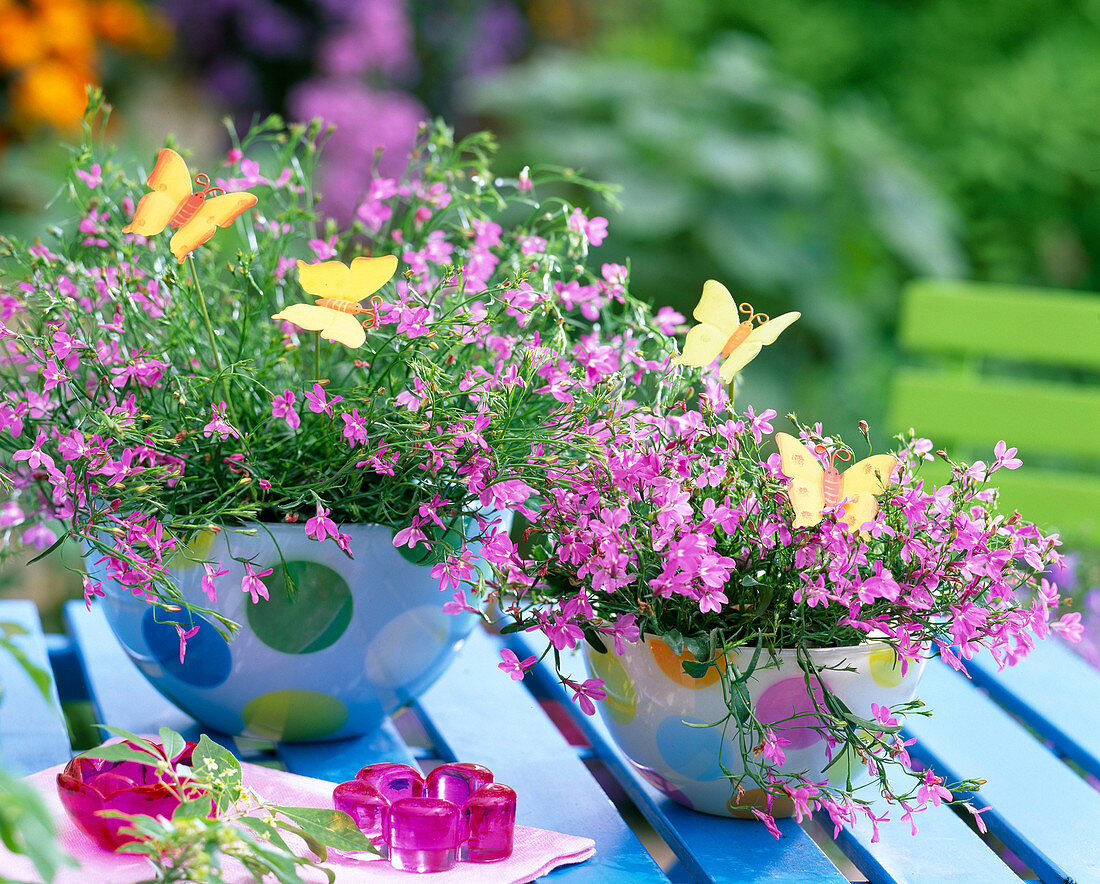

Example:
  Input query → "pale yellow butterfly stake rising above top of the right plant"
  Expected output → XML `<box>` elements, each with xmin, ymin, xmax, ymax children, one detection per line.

<box><xmin>672</xmin><ymin>279</ymin><xmax>802</xmax><ymax>384</ymax></box>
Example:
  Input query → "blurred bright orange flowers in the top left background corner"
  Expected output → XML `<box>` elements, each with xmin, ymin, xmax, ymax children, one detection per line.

<box><xmin>0</xmin><ymin>0</ymin><xmax>172</xmax><ymax>130</ymax></box>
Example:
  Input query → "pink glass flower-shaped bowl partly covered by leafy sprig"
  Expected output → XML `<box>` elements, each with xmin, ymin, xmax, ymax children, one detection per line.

<box><xmin>57</xmin><ymin>743</ymin><xmax>201</xmax><ymax>850</ymax></box>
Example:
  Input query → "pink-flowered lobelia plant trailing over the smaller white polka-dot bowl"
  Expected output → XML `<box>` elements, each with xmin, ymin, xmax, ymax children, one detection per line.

<box><xmin>468</xmin><ymin>378</ymin><xmax>1080</xmax><ymax>837</ymax></box>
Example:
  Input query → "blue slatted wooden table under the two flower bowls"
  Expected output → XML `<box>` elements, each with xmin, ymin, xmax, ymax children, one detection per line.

<box><xmin>0</xmin><ymin>600</ymin><xmax>1100</xmax><ymax>884</ymax></box>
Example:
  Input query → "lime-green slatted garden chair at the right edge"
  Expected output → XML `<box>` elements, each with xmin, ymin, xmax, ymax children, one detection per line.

<box><xmin>888</xmin><ymin>279</ymin><xmax>1100</xmax><ymax>548</ymax></box>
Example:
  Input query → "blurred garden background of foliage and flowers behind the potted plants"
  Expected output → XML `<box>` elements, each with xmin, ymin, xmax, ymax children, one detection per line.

<box><xmin>0</xmin><ymin>0</ymin><xmax>1100</xmax><ymax>470</ymax></box>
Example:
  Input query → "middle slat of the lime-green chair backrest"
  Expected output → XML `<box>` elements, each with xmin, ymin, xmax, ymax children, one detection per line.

<box><xmin>888</xmin><ymin>367</ymin><xmax>1100</xmax><ymax>464</ymax></box>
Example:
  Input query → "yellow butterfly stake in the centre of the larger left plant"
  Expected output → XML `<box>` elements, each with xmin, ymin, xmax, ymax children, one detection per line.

<box><xmin>272</xmin><ymin>255</ymin><xmax>397</xmax><ymax>349</ymax></box>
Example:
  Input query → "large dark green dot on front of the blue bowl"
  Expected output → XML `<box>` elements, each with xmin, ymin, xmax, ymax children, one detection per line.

<box><xmin>245</xmin><ymin>562</ymin><xmax>354</xmax><ymax>654</ymax></box>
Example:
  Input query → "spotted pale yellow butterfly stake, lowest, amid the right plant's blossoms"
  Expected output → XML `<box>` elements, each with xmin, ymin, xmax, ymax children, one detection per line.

<box><xmin>776</xmin><ymin>433</ymin><xmax>898</xmax><ymax>531</ymax></box>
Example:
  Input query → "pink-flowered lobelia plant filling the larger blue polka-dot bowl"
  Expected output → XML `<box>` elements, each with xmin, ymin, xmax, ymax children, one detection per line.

<box><xmin>0</xmin><ymin>93</ymin><xmax>671</xmax><ymax>654</ymax></box>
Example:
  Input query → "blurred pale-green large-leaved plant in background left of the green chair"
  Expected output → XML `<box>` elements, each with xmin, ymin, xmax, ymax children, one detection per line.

<box><xmin>473</xmin><ymin>34</ymin><xmax>966</xmax><ymax>435</ymax></box>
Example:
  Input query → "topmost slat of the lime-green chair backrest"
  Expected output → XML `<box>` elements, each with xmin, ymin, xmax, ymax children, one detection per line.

<box><xmin>899</xmin><ymin>279</ymin><xmax>1100</xmax><ymax>369</ymax></box>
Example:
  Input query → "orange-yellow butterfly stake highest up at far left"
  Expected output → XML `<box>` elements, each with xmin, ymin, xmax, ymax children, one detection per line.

<box><xmin>122</xmin><ymin>147</ymin><xmax>256</xmax><ymax>264</ymax></box>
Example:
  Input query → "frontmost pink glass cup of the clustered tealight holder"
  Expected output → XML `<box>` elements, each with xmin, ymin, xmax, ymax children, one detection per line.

<box><xmin>383</xmin><ymin>797</ymin><xmax>462</xmax><ymax>872</ymax></box>
